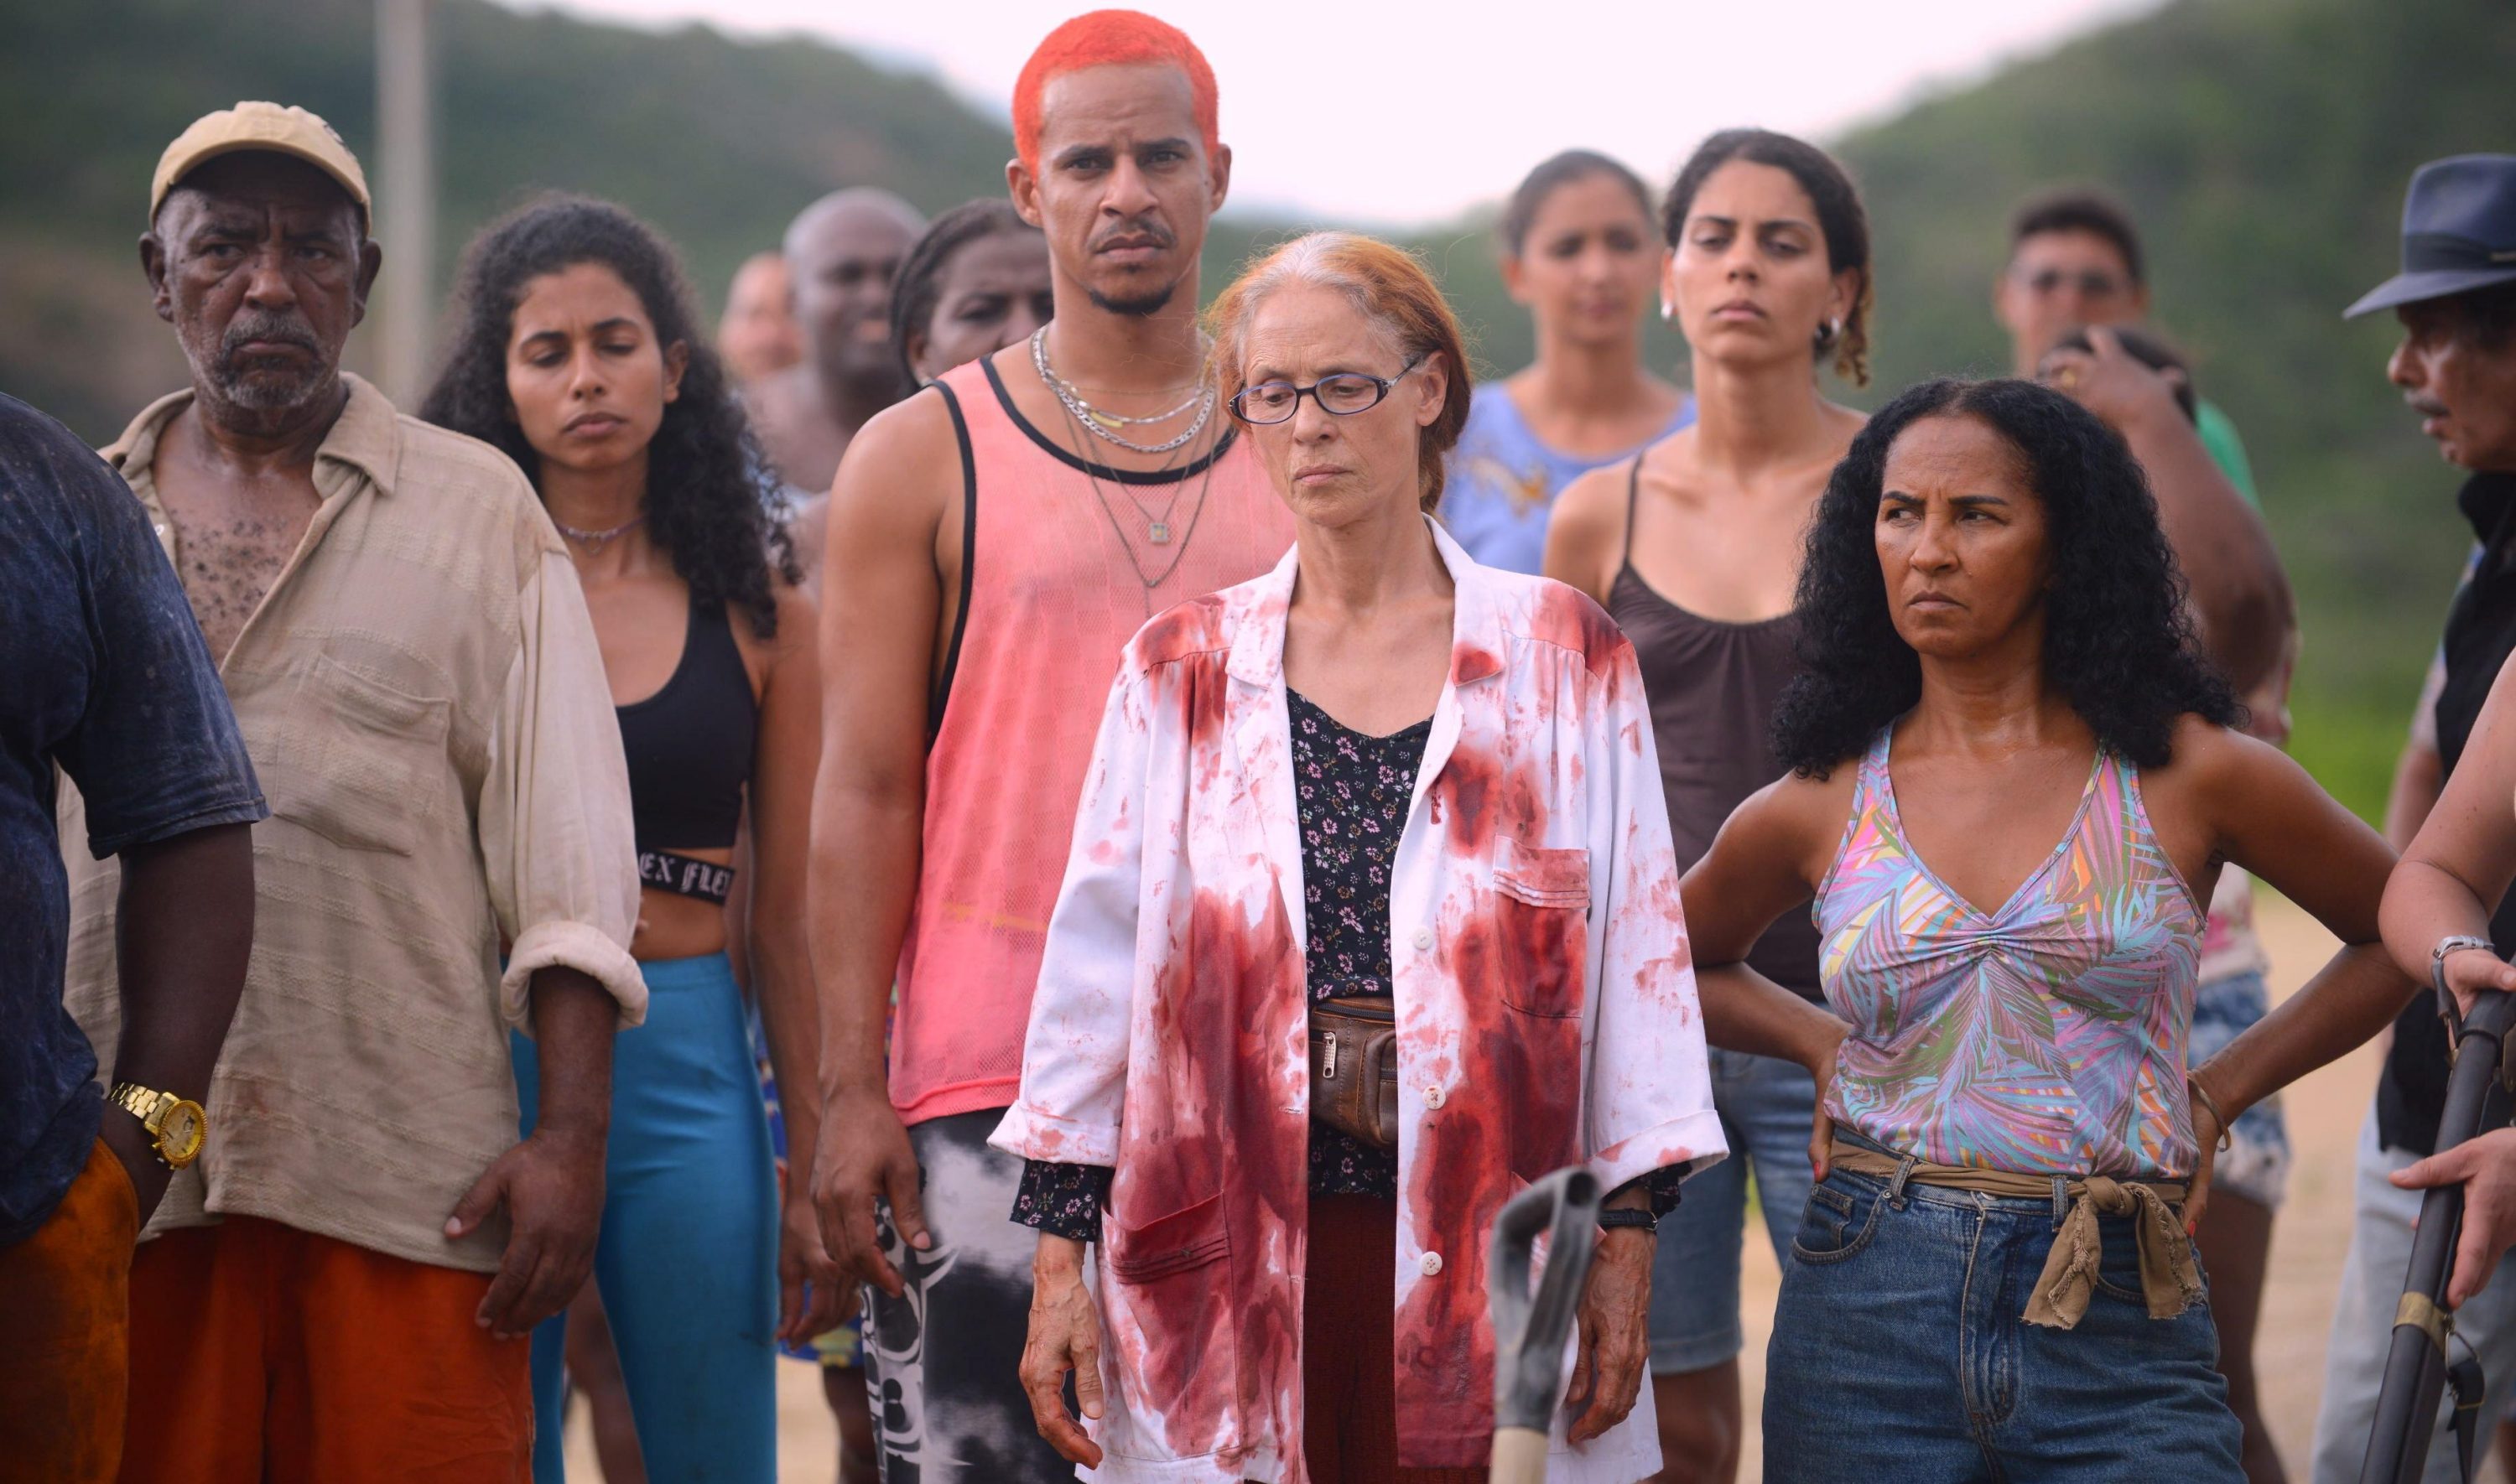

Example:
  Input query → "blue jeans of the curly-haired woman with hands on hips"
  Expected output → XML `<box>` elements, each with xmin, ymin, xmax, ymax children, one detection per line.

<box><xmin>1764</xmin><ymin>1147</ymin><xmax>2244</xmax><ymax>1484</ymax></box>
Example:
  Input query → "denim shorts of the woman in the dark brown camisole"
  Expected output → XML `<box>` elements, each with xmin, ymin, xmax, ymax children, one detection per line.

<box><xmin>1650</xmin><ymin>1046</ymin><xmax>1817</xmax><ymax>1376</ymax></box>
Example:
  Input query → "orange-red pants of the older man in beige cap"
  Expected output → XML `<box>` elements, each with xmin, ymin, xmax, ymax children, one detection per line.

<box><xmin>123</xmin><ymin>1217</ymin><xmax>533</xmax><ymax>1484</ymax></box>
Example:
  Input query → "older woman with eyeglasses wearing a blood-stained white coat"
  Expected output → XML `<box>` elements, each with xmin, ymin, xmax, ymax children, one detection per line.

<box><xmin>996</xmin><ymin>231</ymin><xmax>1726</xmax><ymax>1484</ymax></box>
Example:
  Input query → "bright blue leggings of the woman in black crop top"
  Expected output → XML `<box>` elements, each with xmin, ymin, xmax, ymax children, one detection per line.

<box><xmin>513</xmin><ymin>953</ymin><xmax>777</xmax><ymax>1484</ymax></box>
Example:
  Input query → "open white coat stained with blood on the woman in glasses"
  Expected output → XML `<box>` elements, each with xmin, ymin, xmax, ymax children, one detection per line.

<box><xmin>994</xmin><ymin>523</ymin><xmax>1726</xmax><ymax>1484</ymax></box>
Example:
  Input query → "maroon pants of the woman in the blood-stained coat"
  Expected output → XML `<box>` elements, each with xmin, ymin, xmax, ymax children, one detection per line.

<box><xmin>1301</xmin><ymin>1195</ymin><xmax>1484</xmax><ymax>1484</ymax></box>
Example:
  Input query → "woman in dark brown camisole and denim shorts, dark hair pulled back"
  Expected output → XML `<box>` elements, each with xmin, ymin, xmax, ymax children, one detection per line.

<box><xmin>1547</xmin><ymin>128</ymin><xmax>1872</xmax><ymax>1484</ymax></box>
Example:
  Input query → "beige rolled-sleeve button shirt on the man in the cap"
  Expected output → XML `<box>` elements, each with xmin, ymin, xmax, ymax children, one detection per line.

<box><xmin>63</xmin><ymin>377</ymin><xmax>647</xmax><ymax>1273</ymax></box>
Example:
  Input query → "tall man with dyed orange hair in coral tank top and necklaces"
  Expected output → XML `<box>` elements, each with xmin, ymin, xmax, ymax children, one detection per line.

<box><xmin>810</xmin><ymin>10</ymin><xmax>1293</xmax><ymax>1484</ymax></box>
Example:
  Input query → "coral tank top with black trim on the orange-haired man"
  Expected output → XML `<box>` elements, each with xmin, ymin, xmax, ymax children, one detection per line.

<box><xmin>891</xmin><ymin>357</ymin><xmax>1293</xmax><ymax>1122</ymax></box>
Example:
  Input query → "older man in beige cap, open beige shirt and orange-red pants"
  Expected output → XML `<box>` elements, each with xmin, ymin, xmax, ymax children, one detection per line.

<box><xmin>65</xmin><ymin>103</ymin><xmax>647</xmax><ymax>1484</ymax></box>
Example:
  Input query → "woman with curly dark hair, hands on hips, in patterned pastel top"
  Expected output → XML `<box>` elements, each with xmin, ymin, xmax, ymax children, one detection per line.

<box><xmin>1683</xmin><ymin>380</ymin><xmax>2410</xmax><ymax>1484</ymax></box>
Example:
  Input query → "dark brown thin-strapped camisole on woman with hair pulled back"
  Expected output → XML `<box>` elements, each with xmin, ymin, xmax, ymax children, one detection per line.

<box><xmin>1608</xmin><ymin>458</ymin><xmax>1822</xmax><ymax>999</ymax></box>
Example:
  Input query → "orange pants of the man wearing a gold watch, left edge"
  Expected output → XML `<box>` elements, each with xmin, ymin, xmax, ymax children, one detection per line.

<box><xmin>0</xmin><ymin>1139</ymin><xmax>141</xmax><ymax>1484</ymax></box>
